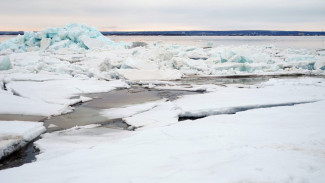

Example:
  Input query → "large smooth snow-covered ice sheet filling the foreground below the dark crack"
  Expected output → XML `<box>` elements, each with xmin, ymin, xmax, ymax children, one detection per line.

<box><xmin>0</xmin><ymin>97</ymin><xmax>325</xmax><ymax>183</ymax></box>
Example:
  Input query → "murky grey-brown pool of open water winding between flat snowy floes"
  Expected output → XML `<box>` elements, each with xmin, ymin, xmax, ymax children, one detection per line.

<box><xmin>44</xmin><ymin>87</ymin><xmax>195</xmax><ymax>132</ymax></box>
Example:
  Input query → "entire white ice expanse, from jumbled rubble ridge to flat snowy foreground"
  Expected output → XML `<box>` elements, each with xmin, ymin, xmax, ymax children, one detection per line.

<box><xmin>0</xmin><ymin>24</ymin><xmax>325</xmax><ymax>183</ymax></box>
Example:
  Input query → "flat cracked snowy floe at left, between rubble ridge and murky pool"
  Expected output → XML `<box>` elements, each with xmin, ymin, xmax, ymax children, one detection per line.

<box><xmin>0</xmin><ymin>73</ymin><xmax>129</xmax><ymax>116</ymax></box>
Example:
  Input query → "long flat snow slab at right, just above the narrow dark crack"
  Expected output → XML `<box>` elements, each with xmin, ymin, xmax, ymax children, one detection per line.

<box><xmin>175</xmin><ymin>78</ymin><xmax>325</xmax><ymax>117</ymax></box>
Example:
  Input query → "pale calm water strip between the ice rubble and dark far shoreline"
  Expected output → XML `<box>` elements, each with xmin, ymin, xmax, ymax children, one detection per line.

<box><xmin>0</xmin><ymin>35</ymin><xmax>325</xmax><ymax>49</ymax></box>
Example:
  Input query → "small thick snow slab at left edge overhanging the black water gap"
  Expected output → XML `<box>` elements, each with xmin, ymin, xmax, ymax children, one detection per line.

<box><xmin>0</xmin><ymin>121</ymin><xmax>45</xmax><ymax>159</ymax></box>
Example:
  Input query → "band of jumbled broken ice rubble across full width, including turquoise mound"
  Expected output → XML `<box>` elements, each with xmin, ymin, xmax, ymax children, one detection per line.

<box><xmin>0</xmin><ymin>24</ymin><xmax>325</xmax><ymax>80</ymax></box>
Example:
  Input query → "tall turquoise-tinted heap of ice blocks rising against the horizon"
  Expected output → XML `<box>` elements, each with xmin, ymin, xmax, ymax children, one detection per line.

<box><xmin>0</xmin><ymin>23</ymin><xmax>116</xmax><ymax>52</ymax></box>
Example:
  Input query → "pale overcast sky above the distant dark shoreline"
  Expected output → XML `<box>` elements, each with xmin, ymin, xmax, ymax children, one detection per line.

<box><xmin>0</xmin><ymin>0</ymin><xmax>325</xmax><ymax>31</ymax></box>
